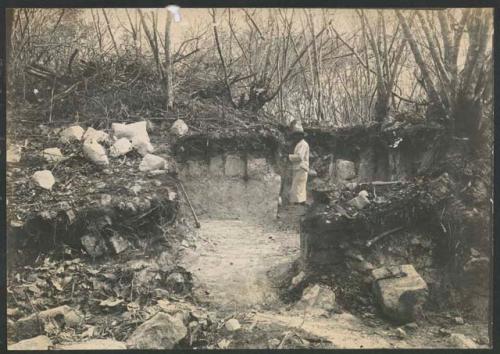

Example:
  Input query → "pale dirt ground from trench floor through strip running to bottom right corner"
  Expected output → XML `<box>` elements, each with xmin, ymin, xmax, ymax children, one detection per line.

<box><xmin>177</xmin><ymin>209</ymin><xmax>487</xmax><ymax>348</ymax></box>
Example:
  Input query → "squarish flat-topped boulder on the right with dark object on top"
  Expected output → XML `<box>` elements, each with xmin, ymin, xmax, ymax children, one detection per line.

<box><xmin>372</xmin><ymin>264</ymin><xmax>428</xmax><ymax>323</ymax></box>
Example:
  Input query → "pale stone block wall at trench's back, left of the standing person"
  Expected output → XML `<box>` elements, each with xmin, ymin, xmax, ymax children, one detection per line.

<box><xmin>178</xmin><ymin>154</ymin><xmax>281</xmax><ymax>220</ymax></box>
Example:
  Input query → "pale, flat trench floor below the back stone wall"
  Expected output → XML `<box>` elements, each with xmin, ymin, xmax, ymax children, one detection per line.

<box><xmin>183</xmin><ymin>219</ymin><xmax>300</xmax><ymax>311</ymax></box>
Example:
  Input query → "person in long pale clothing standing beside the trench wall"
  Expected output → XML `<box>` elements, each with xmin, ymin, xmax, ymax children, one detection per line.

<box><xmin>288</xmin><ymin>124</ymin><xmax>309</xmax><ymax>204</ymax></box>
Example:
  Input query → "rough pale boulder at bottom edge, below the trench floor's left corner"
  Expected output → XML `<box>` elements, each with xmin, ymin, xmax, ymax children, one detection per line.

<box><xmin>127</xmin><ymin>312</ymin><xmax>187</xmax><ymax>349</ymax></box>
